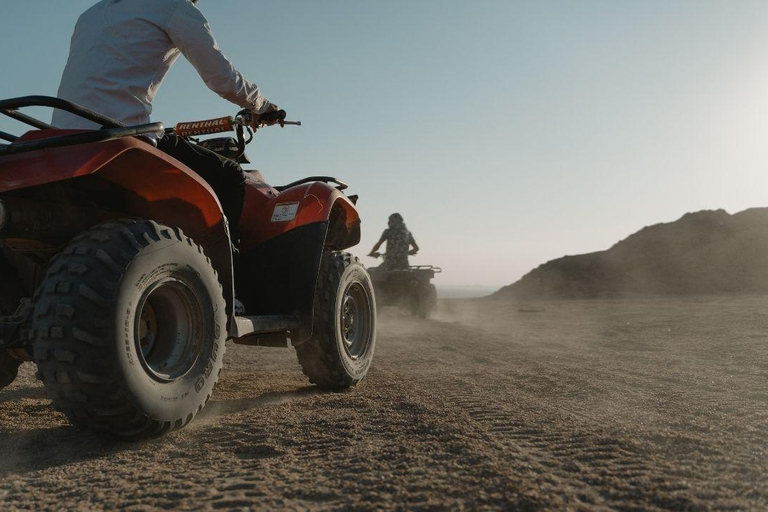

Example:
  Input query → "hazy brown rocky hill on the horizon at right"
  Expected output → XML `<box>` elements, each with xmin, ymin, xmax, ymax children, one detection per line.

<box><xmin>491</xmin><ymin>208</ymin><xmax>768</xmax><ymax>299</ymax></box>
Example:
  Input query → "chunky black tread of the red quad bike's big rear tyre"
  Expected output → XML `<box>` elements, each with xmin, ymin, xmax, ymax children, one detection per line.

<box><xmin>30</xmin><ymin>219</ymin><xmax>224</xmax><ymax>439</ymax></box>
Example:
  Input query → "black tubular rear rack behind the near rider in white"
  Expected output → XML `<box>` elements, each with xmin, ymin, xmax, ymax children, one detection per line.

<box><xmin>0</xmin><ymin>96</ymin><xmax>164</xmax><ymax>156</ymax></box>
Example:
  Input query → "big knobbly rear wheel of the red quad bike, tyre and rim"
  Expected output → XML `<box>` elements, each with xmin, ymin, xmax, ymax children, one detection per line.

<box><xmin>32</xmin><ymin>219</ymin><xmax>227</xmax><ymax>439</ymax></box>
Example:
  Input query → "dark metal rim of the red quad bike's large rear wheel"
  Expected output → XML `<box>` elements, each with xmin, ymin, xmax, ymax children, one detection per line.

<box><xmin>134</xmin><ymin>278</ymin><xmax>204</xmax><ymax>382</ymax></box>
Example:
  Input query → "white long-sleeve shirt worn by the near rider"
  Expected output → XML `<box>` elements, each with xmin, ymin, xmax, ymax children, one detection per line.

<box><xmin>52</xmin><ymin>0</ymin><xmax>269</xmax><ymax>129</ymax></box>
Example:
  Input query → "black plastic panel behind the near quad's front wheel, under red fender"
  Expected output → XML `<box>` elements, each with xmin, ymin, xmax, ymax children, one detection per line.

<box><xmin>235</xmin><ymin>221</ymin><xmax>328</xmax><ymax>345</ymax></box>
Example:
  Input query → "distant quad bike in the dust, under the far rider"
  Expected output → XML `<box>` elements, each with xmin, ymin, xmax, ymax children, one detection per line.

<box><xmin>368</xmin><ymin>253</ymin><xmax>443</xmax><ymax>318</ymax></box>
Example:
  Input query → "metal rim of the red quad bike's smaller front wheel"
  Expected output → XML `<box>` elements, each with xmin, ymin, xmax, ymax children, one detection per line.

<box><xmin>339</xmin><ymin>282</ymin><xmax>373</xmax><ymax>359</ymax></box>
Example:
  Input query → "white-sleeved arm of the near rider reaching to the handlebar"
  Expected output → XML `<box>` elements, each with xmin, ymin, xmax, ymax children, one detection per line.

<box><xmin>166</xmin><ymin>2</ymin><xmax>270</xmax><ymax>114</ymax></box>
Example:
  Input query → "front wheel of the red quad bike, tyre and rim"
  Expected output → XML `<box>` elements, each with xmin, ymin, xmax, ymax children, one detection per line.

<box><xmin>296</xmin><ymin>252</ymin><xmax>376</xmax><ymax>389</ymax></box>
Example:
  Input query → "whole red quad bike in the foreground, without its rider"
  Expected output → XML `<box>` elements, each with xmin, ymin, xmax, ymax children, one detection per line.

<box><xmin>0</xmin><ymin>96</ymin><xmax>376</xmax><ymax>438</ymax></box>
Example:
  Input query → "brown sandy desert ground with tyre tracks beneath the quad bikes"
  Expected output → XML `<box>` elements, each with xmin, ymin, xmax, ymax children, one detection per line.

<box><xmin>0</xmin><ymin>298</ymin><xmax>768</xmax><ymax>510</ymax></box>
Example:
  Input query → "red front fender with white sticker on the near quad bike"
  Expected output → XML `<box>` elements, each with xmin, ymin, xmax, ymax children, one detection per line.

<box><xmin>240</xmin><ymin>173</ymin><xmax>360</xmax><ymax>251</ymax></box>
